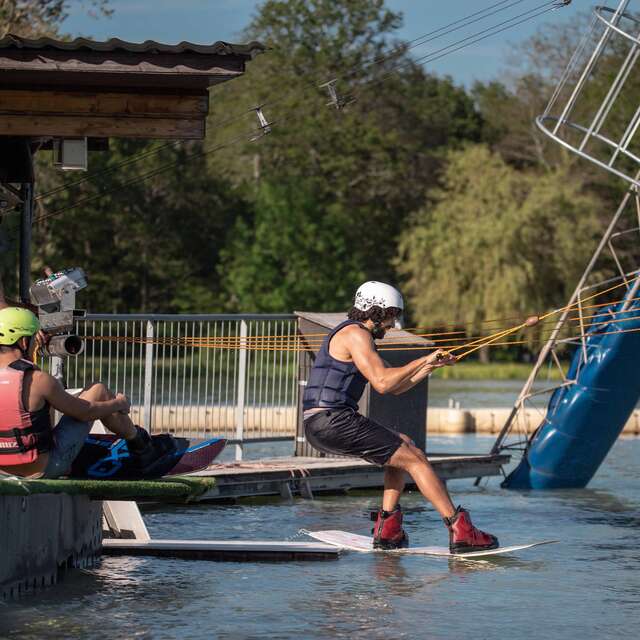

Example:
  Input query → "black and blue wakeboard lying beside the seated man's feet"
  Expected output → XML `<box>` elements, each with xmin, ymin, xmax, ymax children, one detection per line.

<box><xmin>70</xmin><ymin>433</ymin><xmax>226</xmax><ymax>480</ymax></box>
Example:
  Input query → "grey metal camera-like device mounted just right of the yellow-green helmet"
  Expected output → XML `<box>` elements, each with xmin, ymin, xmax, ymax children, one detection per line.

<box><xmin>29</xmin><ymin>267</ymin><xmax>87</xmax><ymax>358</ymax></box>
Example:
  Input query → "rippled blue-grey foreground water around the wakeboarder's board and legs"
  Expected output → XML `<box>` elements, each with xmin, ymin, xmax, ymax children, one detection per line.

<box><xmin>0</xmin><ymin>437</ymin><xmax>640</xmax><ymax>640</ymax></box>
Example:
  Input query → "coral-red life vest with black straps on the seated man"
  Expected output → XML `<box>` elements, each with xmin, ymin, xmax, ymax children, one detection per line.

<box><xmin>0</xmin><ymin>360</ymin><xmax>53</xmax><ymax>466</ymax></box>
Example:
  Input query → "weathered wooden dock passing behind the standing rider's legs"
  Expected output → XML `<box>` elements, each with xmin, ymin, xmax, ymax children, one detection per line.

<box><xmin>190</xmin><ymin>454</ymin><xmax>510</xmax><ymax>501</ymax></box>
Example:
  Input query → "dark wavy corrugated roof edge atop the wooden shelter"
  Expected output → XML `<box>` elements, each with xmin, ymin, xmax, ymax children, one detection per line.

<box><xmin>0</xmin><ymin>34</ymin><xmax>265</xmax><ymax>58</ymax></box>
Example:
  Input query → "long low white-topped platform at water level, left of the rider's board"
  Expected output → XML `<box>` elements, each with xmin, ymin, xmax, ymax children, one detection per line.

<box><xmin>102</xmin><ymin>539</ymin><xmax>341</xmax><ymax>561</ymax></box>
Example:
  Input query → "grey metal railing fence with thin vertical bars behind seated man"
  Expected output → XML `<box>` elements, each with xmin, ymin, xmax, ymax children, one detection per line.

<box><xmin>60</xmin><ymin>314</ymin><xmax>298</xmax><ymax>458</ymax></box>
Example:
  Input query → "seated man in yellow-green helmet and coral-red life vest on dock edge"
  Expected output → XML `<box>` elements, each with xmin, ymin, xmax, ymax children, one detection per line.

<box><xmin>0</xmin><ymin>307</ymin><xmax>155</xmax><ymax>478</ymax></box>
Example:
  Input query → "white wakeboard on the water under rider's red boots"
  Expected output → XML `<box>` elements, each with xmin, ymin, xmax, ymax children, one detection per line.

<box><xmin>304</xmin><ymin>531</ymin><xmax>559</xmax><ymax>558</ymax></box>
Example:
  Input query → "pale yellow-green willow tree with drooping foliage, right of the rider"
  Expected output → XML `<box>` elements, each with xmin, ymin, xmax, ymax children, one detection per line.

<box><xmin>396</xmin><ymin>145</ymin><xmax>601</xmax><ymax>331</ymax></box>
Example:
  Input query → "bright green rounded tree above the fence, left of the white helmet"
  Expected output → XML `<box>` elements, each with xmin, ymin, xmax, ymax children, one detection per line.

<box><xmin>219</xmin><ymin>181</ymin><xmax>364</xmax><ymax>312</ymax></box>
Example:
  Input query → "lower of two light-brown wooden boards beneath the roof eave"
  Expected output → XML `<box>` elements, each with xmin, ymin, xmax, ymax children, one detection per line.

<box><xmin>0</xmin><ymin>115</ymin><xmax>205</xmax><ymax>140</ymax></box>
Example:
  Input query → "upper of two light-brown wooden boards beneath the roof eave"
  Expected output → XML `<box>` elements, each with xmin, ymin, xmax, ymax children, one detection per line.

<box><xmin>0</xmin><ymin>89</ymin><xmax>209</xmax><ymax>119</ymax></box>
